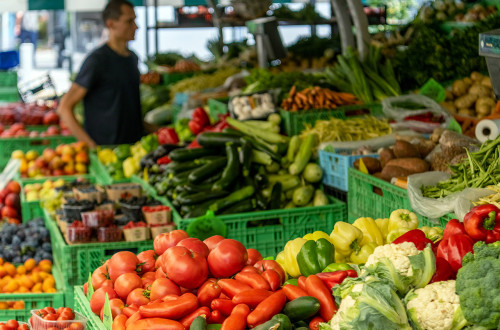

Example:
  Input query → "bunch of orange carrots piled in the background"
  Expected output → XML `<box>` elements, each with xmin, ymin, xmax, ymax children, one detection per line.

<box><xmin>281</xmin><ymin>86</ymin><xmax>361</xmax><ymax>111</ymax></box>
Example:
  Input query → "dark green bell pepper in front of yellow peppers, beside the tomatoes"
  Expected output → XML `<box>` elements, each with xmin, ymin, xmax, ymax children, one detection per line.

<box><xmin>297</xmin><ymin>238</ymin><xmax>335</xmax><ymax>277</ymax></box>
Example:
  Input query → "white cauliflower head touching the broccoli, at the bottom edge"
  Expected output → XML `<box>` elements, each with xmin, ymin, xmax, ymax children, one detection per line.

<box><xmin>405</xmin><ymin>281</ymin><xmax>467</xmax><ymax>330</ymax></box>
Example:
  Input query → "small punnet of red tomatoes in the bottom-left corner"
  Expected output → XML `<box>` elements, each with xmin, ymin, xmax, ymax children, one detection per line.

<box><xmin>30</xmin><ymin>307</ymin><xmax>85</xmax><ymax>330</ymax></box>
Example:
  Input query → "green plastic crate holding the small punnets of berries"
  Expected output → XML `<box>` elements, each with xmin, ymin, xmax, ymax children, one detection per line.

<box><xmin>44</xmin><ymin>210</ymin><xmax>153</xmax><ymax>287</ymax></box>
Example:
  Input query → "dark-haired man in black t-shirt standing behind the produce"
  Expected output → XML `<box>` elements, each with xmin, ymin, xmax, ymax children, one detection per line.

<box><xmin>58</xmin><ymin>0</ymin><xmax>143</xmax><ymax>147</ymax></box>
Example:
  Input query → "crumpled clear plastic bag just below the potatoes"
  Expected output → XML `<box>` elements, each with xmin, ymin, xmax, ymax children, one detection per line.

<box><xmin>382</xmin><ymin>94</ymin><xmax>452</xmax><ymax>133</ymax></box>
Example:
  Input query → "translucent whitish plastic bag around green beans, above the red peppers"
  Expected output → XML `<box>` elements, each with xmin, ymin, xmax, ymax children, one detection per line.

<box><xmin>407</xmin><ymin>172</ymin><xmax>494</xmax><ymax>221</ymax></box>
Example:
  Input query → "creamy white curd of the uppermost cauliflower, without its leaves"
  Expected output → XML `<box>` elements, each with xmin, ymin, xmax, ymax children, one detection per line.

<box><xmin>365</xmin><ymin>242</ymin><xmax>420</xmax><ymax>276</ymax></box>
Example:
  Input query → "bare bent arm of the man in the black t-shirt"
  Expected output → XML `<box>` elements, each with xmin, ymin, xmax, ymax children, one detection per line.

<box><xmin>57</xmin><ymin>83</ymin><xmax>97</xmax><ymax>148</ymax></box>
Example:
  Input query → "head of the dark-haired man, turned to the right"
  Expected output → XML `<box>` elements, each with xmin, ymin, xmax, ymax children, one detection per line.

<box><xmin>102</xmin><ymin>0</ymin><xmax>137</xmax><ymax>41</ymax></box>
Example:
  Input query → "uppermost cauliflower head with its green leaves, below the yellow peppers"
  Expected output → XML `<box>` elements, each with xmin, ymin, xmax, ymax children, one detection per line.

<box><xmin>362</xmin><ymin>242</ymin><xmax>436</xmax><ymax>297</ymax></box>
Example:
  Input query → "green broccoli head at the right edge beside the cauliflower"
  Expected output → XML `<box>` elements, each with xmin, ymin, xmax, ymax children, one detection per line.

<box><xmin>456</xmin><ymin>242</ymin><xmax>500</xmax><ymax>329</ymax></box>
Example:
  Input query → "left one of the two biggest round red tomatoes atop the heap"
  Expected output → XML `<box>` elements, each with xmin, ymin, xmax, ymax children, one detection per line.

<box><xmin>161</xmin><ymin>243</ymin><xmax>207</xmax><ymax>289</ymax></box>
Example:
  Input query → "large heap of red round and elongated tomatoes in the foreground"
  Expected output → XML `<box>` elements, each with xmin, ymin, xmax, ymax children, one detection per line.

<box><xmin>83</xmin><ymin>230</ymin><xmax>333</xmax><ymax>330</ymax></box>
